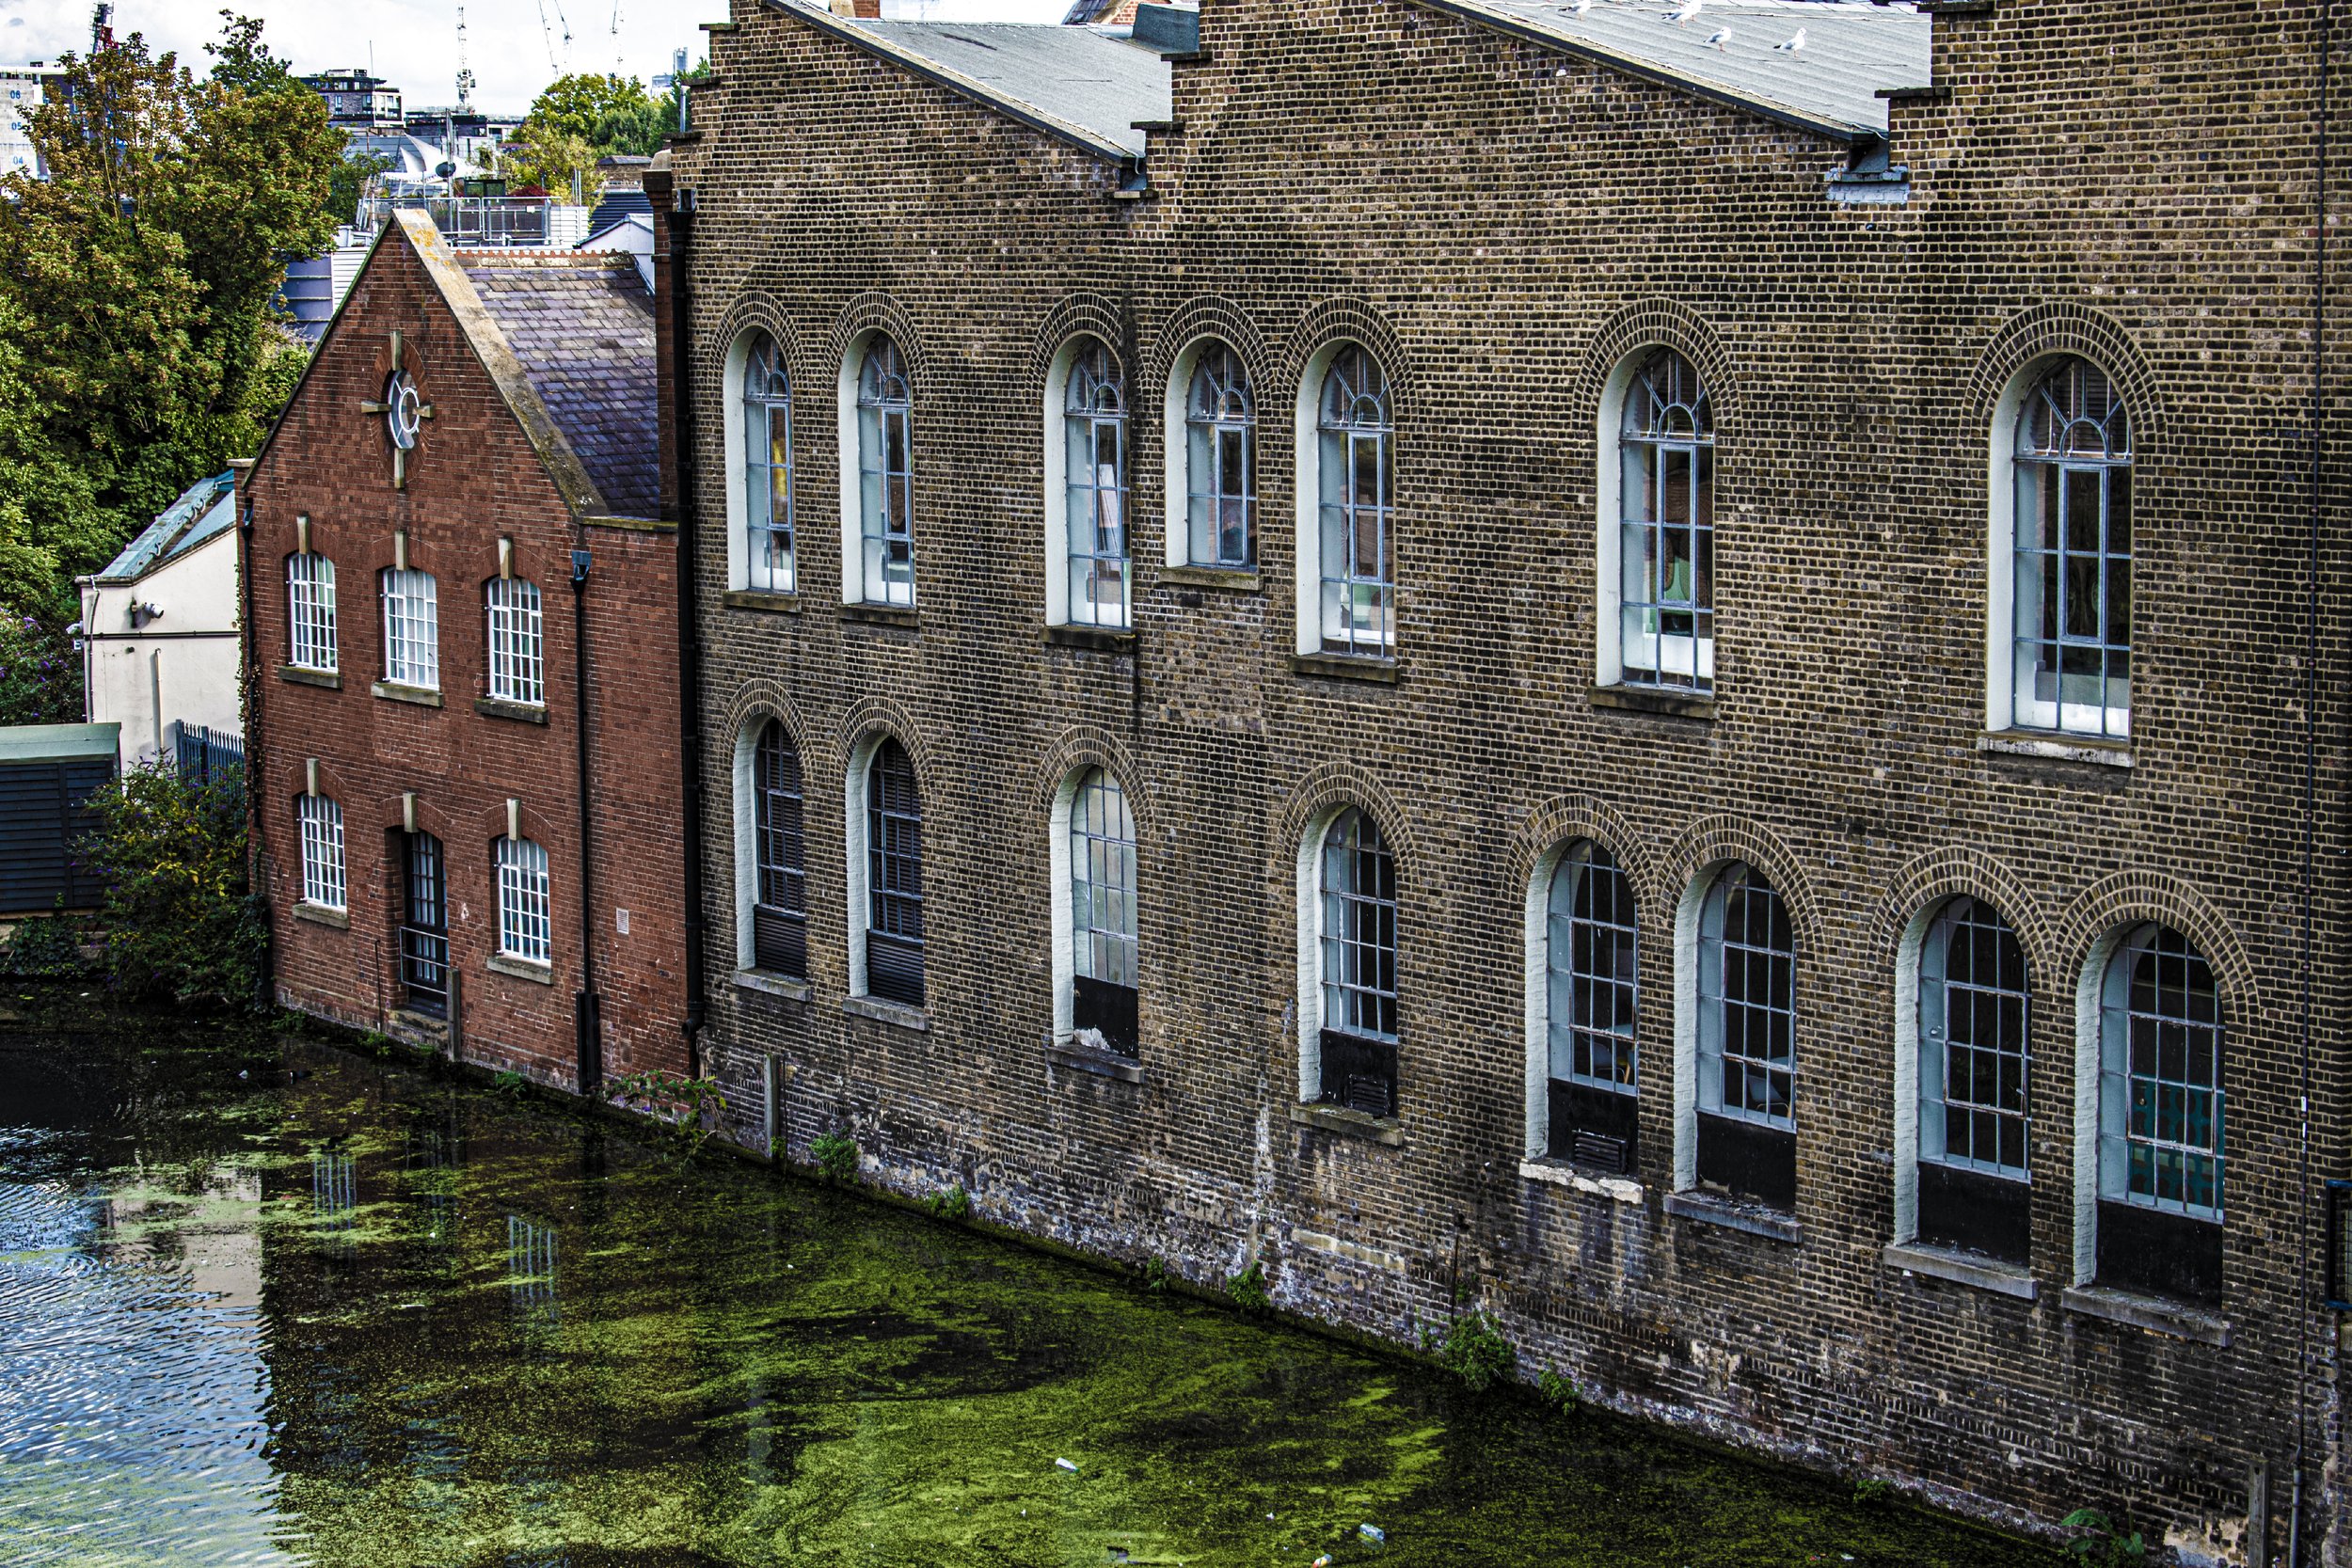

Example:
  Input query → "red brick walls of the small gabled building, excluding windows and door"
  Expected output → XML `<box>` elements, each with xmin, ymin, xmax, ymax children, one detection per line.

<box><xmin>245</xmin><ymin>232</ymin><xmax>687</xmax><ymax>1086</ymax></box>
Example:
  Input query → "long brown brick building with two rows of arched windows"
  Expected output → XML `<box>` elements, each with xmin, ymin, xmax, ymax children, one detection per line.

<box><xmin>647</xmin><ymin>0</ymin><xmax>2352</xmax><ymax>1563</ymax></box>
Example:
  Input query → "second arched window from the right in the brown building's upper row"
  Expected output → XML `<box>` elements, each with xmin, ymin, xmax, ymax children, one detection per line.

<box><xmin>1602</xmin><ymin>348</ymin><xmax>1715</xmax><ymax>691</ymax></box>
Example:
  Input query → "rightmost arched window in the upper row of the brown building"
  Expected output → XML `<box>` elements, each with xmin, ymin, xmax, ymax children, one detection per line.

<box><xmin>1997</xmin><ymin>357</ymin><xmax>2131</xmax><ymax>738</ymax></box>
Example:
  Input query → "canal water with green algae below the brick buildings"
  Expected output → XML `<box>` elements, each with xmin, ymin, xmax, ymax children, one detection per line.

<box><xmin>0</xmin><ymin>1020</ymin><xmax>2054</xmax><ymax>1568</ymax></box>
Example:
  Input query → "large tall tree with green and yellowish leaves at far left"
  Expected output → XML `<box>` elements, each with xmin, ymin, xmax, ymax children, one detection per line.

<box><xmin>0</xmin><ymin>16</ymin><xmax>343</xmax><ymax>690</ymax></box>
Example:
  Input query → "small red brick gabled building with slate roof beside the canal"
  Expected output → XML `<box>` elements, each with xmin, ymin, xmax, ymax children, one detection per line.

<box><xmin>243</xmin><ymin>212</ymin><xmax>690</xmax><ymax>1088</ymax></box>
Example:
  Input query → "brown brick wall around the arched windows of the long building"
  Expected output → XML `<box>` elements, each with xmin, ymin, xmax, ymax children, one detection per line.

<box><xmin>677</xmin><ymin>0</ymin><xmax>2345</xmax><ymax>1561</ymax></box>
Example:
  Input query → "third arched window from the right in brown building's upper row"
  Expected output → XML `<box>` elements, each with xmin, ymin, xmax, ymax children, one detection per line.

<box><xmin>1301</xmin><ymin>343</ymin><xmax>1397</xmax><ymax>658</ymax></box>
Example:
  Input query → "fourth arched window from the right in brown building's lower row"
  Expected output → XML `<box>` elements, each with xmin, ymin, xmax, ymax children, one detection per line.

<box><xmin>1543</xmin><ymin>839</ymin><xmax>1640</xmax><ymax>1173</ymax></box>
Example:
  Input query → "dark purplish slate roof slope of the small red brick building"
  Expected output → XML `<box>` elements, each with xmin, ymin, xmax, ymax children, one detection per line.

<box><xmin>456</xmin><ymin>251</ymin><xmax>661</xmax><ymax>517</ymax></box>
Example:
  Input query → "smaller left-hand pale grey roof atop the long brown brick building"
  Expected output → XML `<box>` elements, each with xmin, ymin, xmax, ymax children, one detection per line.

<box><xmin>771</xmin><ymin>0</ymin><xmax>1169</xmax><ymax>160</ymax></box>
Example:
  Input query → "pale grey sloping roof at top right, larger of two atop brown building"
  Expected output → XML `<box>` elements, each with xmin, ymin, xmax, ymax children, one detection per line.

<box><xmin>1392</xmin><ymin>0</ymin><xmax>1931</xmax><ymax>138</ymax></box>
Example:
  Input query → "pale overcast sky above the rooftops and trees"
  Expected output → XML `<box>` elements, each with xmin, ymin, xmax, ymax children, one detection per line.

<box><xmin>0</xmin><ymin>0</ymin><xmax>1068</xmax><ymax>113</ymax></box>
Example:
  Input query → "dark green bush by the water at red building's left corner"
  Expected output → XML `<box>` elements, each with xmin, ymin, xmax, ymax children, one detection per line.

<box><xmin>83</xmin><ymin>762</ymin><xmax>268</xmax><ymax>1006</ymax></box>
